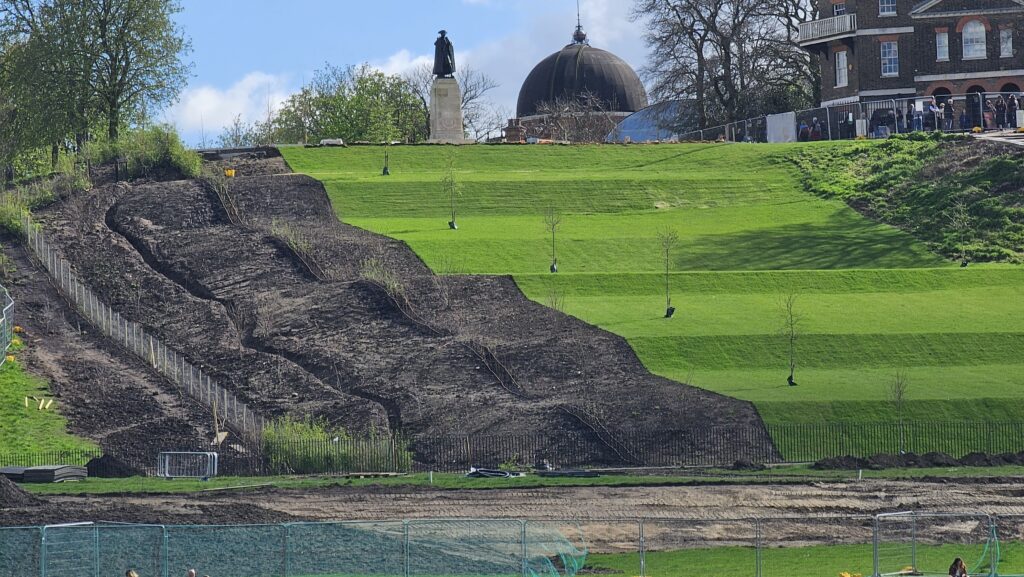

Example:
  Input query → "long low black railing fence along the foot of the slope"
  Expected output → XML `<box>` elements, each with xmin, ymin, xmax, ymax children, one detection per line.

<box><xmin>6</xmin><ymin>421</ymin><xmax>1024</xmax><ymax>477</ymax></box>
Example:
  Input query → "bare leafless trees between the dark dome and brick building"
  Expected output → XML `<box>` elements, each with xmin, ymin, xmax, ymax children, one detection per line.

<box><xmin>633</xmin><ymin>0</ymin><xmax>820</xmax><ymax>128</ymax></box>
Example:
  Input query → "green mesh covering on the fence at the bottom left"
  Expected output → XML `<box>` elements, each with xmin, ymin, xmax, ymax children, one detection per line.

<box><xmin>0</xmin><ymin>521</ymin><xmax>586</xmax><ymax>577</ymax></box>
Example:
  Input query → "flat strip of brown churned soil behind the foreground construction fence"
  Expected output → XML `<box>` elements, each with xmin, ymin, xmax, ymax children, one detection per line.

<box><xmin>6</xmin><ymin>480</ymin><xmax>1024</xmax><ymax>552</ymax></box>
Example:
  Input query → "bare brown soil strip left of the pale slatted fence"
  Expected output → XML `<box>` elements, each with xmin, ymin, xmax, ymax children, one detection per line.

<box><xmin>0</xmin><ymin>237</ymin><xmax>246</xmax><ymax>467</ymax></box>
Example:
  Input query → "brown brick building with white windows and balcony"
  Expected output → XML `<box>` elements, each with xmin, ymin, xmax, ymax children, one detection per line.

<box><xmin>800</xmin><ymin>0</ymin><xmax>1024</xmax><ymax>106</ymax></box>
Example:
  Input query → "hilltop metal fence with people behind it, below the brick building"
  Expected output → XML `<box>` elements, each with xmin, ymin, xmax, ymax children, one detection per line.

<box><xmin>678</xmin><ymin>92</ymin><xmax>1024</xmax><ymax>142</ymax></box>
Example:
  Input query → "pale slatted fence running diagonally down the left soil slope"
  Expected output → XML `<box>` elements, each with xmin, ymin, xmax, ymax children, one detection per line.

<box><xmin>23</xmin><ymin>213</ymin><xmax>265</xmax><ymax>441</ymax></box>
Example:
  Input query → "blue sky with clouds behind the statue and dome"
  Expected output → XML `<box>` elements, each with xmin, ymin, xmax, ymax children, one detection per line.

<box><xmin>161</xmin><ymin>0</ymin><xmax>647</xmax><ymax>146</ymax></box>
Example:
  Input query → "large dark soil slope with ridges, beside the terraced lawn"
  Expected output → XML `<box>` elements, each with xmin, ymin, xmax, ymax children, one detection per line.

<box><xmin>28</xmin><ymin>158</ymin><xmax>770</xmax><ymax>464</ymax></box>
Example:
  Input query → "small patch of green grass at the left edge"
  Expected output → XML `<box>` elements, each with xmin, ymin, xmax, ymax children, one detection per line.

<box><xmin>0</xmin><ymin>346</ymin><xmax>97</xmax><ymax>464</ymax></box>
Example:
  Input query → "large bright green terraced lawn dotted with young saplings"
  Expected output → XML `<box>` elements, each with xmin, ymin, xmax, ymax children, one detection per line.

<box><xmin>283</xmin><ymin>142</ymin><xmax>1024</xmax><ymax>450</ymax></box>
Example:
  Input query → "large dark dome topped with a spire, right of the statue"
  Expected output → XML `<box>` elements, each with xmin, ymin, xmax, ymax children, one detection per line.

<box><xmin>516</xmin><ymin>41</ymin><xmax>647</xmax><ymax>118</ymax></box>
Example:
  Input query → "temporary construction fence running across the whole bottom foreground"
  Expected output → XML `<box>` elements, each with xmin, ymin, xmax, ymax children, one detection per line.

<box><xmin>6</xmin><ymin>512</ymin><xmax>1024</xmax><ymax>577</ymax></box>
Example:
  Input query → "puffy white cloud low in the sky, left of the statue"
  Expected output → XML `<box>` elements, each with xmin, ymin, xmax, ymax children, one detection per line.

<box><xmin>167</xmin><ymin>72</ymin><xmax>297</xmax><ymax>142</ymax></box>
